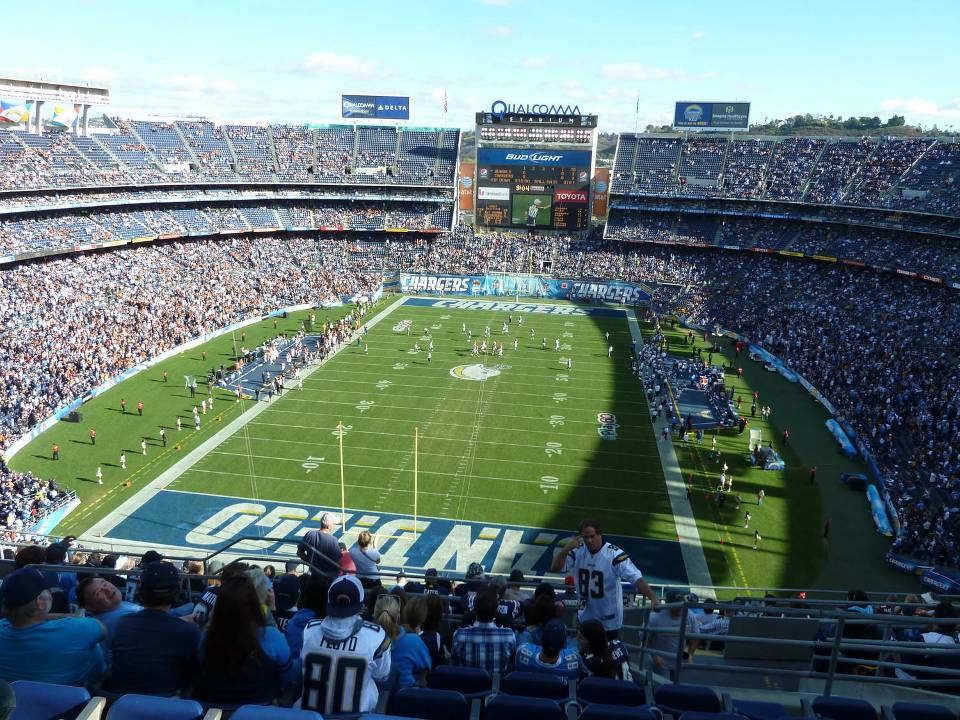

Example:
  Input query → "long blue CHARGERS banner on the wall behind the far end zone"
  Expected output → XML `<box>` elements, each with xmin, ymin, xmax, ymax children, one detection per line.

<box><xmin>400</xmin><ymin>273</ymin><xmax>650</xmax><ymax>305</ymax></box>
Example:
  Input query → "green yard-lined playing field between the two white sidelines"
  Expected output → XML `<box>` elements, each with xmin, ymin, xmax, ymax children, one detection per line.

<box><xmin>161</xmin><ymin>298</ymin><xmax>675</xmax><ymax>539</ymax></box>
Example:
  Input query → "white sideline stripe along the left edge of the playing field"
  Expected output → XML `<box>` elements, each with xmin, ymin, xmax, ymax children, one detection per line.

<box><xmin>79</xmin><ymin>296</ymin><xmax>407</xmax><ymax>541</ymax></box>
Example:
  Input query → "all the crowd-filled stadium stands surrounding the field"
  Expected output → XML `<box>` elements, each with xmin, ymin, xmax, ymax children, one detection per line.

<box><xmin>0</xmin><ymin>118</ymin><xmax>960</xmax><ymax>719</ymax></box>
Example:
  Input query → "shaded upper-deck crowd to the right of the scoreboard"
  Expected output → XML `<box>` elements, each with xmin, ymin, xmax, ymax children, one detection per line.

<box><xmin>611</xmin><ymin>134</ymin><xmax>960</xmax><ymax>215</ymax></box>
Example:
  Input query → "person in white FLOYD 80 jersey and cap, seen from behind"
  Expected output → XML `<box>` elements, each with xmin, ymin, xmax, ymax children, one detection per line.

<box><xmin>295</xmin><ymin>575</ymin><xmax>390</xmax><ymax>715</ymax></box>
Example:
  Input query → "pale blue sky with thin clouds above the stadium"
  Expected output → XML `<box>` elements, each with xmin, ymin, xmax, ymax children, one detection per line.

<box><xmin>0</xmin><ymin>0</ymin><xmax>960</xmax><ymax>130</ymax></box>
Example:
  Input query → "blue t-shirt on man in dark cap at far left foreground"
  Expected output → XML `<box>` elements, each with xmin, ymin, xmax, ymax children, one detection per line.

<box><xmin>0</xmin><ymin>617</ymin><xmax>107</xmax><ymax>685</ymax></box>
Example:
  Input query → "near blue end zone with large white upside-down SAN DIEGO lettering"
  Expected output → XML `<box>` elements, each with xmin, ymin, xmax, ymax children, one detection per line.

<box><xmin>104</xmin><ymin>490</ymin><xmax>687</xmax><ymax>585</ymax></box>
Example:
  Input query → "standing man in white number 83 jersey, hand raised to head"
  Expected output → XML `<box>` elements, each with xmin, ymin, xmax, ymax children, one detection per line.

<box><xmin>550</xmin><ymin>520</ymin><xmax>659</xmax><ymax>638</ymax></box>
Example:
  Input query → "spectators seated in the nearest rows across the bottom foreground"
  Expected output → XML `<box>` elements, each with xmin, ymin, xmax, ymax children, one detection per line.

<box><xmin>0</xmin><ymin>528</ymin><xmax>960</xmax><ymax>713</ymax></box>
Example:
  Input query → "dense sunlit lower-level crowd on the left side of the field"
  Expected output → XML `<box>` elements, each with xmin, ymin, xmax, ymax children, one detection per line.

<box><xmin>0</xmin><ymin>237</ymin><xmax>382</xmax><ymax>447</ymax></box>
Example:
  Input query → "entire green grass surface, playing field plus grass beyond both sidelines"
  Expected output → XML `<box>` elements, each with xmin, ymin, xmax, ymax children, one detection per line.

<box><xmin>11</xmin><ymin>298</ymin><xmax>924</xmax><ymax>589</ymax></box>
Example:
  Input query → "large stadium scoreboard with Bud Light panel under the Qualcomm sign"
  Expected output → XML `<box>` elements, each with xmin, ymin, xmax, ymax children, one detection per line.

<box><xmin>474</xmin><ymin>107</ymin><xmax>597</xmax><ymax>232</ymax></box>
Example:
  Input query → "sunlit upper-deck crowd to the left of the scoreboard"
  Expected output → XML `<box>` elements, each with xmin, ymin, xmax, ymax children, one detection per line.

<box><xmin>0</xmin><ymin>118</ymin><xmax>459</xmax><ymax>190</ymax></box>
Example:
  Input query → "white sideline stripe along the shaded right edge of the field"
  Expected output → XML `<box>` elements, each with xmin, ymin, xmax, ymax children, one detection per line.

<box><xmin>627</xmin><ymin>310</ymin><xmax>716</xmax><ymax>599</ymax></box>
